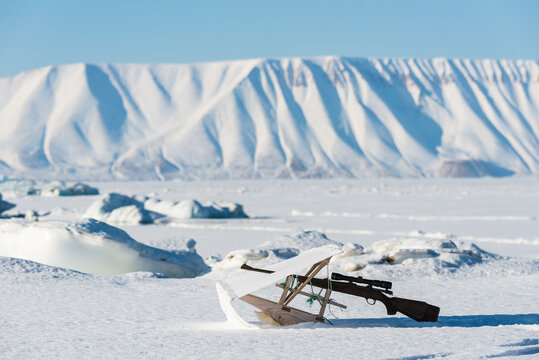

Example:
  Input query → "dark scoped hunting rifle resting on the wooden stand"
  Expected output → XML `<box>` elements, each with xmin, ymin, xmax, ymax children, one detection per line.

<box><xmin>241</xmin><ymin>264</ymin><xmax>440</xmax><ymax>322</ymax></box>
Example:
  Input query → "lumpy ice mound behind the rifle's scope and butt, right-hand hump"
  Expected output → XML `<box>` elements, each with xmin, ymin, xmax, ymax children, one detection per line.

<box><xmin>332</xmin><ymin>238</ymin><xmax>499</xmax><ymax>272</ymax></box>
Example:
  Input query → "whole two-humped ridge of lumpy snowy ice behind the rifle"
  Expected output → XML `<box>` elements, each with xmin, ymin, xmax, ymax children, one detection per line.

<box><xmin>213</xmin><ymin>230</ymin><xmax>500</xmax><ymax>272</ymax></box>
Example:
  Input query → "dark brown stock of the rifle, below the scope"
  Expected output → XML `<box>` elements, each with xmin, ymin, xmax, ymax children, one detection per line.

<box><xmin>298</xmin><ymin>276</ymin><xmax>440</xmax><ymax>322</ymax></box>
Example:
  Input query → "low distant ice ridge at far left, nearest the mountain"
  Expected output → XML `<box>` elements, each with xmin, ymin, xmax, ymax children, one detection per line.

<box><xmin>0</xmin><ymin>179</ymin><xmax>99</xmax><ymax>196</ymax></box>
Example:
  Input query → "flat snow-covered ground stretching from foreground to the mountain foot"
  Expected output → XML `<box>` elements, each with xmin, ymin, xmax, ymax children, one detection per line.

<box><xmin>0</xmin><ymin>178</ymin><xmax>539</xmax><ymax>359</ymax></box>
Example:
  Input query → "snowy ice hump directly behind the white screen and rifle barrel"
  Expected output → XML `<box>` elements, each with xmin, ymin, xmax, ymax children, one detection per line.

<box><xmin>215</xmin><ymin>229</ymin><xmax>342</xmax><ymax>270</ymax></box>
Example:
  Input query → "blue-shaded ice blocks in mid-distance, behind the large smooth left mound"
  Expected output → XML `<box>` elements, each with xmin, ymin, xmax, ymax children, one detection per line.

<box><xmin>82</xmin><ymin>193</ymin><xmax>247</xmax><ymax>224</ymax></box>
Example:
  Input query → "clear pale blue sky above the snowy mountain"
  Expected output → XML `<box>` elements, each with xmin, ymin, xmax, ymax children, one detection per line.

<box><xmin>0</xmin><ymin>0</ymin><xmax>539</xmax><ymax>77</ymax></box>
